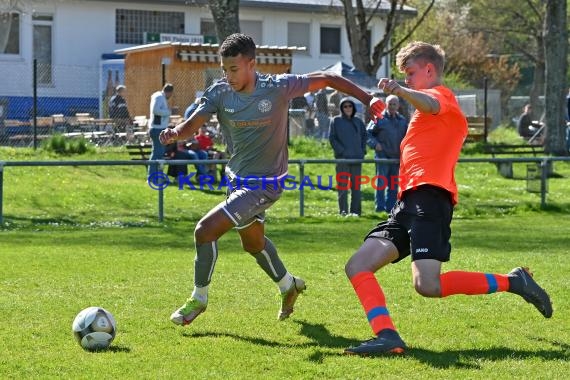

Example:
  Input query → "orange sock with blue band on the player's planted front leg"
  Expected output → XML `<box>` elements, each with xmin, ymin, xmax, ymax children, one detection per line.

<box><xmin>350</xmin><ymin>272</ymin><xmax>396</xmax><ymax>335</ymax></box>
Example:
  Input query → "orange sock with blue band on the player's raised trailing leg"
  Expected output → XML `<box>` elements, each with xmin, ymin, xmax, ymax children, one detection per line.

<box><xmin>439</xmin><ymin>271</ymin><xmax>509</xmax><ymax>297</ymax></box>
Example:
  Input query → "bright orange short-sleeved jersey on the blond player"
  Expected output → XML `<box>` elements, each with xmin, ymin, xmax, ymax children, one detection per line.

<box><xmin>398</xmin><ymin>86</ymin><xmax>467</xmax><ymax>204</ymax></box>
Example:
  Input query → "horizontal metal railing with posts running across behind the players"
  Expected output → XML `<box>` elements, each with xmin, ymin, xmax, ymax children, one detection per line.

<box><xmin>0</xmin><ymin>157</ymin><xmax>570</xmax><ymax>225</ymax></box>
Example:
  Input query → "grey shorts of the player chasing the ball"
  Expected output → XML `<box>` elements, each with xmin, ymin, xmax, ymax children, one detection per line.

<box><xmin>222</xmin><ymin>181</ymin><xmax>283</xmax><ymax>229</ymax></box>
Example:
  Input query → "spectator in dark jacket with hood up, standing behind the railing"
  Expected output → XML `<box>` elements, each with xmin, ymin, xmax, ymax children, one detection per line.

<box><xmin>329</xmin><ymin>98</ymin><xmax>366</xmax><ymax>216</ymax></box>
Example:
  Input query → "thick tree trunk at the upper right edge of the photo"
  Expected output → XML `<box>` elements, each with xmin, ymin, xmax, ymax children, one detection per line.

<box><xmin>544</xmin><ymin>0</ymin><xmax>568</xmax><ymax>156</ymax></box>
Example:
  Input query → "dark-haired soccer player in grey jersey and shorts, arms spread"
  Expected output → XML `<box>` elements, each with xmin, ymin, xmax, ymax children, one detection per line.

<box><xmin>160</xmin><ymin>33</ymin><xmax>384</xmax><ymax>325</ymax></box>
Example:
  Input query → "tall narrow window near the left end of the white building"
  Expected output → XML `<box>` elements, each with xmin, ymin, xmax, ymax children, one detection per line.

<box><xmin>32</xmin><ymin>14</ymin><xmax>53</xmax><ymax>84</ymax></box>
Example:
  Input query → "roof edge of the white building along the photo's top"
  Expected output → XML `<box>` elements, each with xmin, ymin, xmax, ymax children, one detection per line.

<box><xmin>88</xmin><ymin>0</ymin><xmax>417</xmax><ymax>16</ymax></box>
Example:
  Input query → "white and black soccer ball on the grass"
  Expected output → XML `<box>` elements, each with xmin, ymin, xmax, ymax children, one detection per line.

<box><xmin>71</xmin><ymin>306</ymin><xmax>117</xmax><ymax>351</ymax></box>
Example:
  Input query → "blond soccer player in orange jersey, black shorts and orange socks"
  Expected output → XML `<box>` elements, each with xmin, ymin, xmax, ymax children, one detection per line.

<box><xmin>345</xmin><ymin>42</ymin><xmax>552</xmax><ymax>355</ymax></box>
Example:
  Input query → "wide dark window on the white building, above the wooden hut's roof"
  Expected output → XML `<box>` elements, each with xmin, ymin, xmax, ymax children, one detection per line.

<box><xmin>115</xmin><ymin>9</ymin><xmax>184</xmax><ymax>45</ymax></box>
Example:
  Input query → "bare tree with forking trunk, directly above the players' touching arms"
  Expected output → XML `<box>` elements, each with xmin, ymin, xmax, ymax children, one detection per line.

<box><xmin>341</xmin><ymin>0</ymin><xmax>435</xmax><ymax>76</ymax></box>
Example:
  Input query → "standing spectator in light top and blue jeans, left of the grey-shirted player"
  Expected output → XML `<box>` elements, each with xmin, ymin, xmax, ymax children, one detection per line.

<box><xmin>148</xmin><ymin>83</ymin><xmax>174</xmax><ymax>175</ymax></box>
